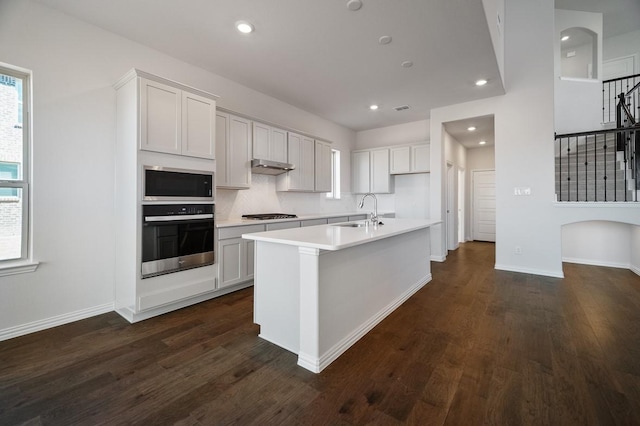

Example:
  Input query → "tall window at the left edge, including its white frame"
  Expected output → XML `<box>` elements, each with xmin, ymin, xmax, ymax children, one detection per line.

<box><xmin>0</xmin><ymin>63</ymin><xmax>35</xmax><ymax>275</ymax></box>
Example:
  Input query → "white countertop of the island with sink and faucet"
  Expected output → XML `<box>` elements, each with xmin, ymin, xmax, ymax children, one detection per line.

<box><xmin>242</xmin><ymin>218</ymin><xmax>441</xmax><ymax>250</ymax></box>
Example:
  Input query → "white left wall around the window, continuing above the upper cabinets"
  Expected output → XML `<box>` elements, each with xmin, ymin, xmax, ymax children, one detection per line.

<box><xmin>0</xmin><ymin>0</ymin><xmax>355</xmax><ymax>339</ymax></box>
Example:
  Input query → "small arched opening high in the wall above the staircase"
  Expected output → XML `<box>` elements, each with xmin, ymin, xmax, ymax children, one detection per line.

<box><xmin>560</xmin><ymin>27</ymin><xmax>600</xmax><ymax>79</ymax></box>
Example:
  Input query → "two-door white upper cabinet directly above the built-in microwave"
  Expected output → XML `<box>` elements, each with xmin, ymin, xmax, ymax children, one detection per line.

<box><xmin>139</xmin><ymin>75</ymin><xmax>216</xmax><ymax>159</ymax></box>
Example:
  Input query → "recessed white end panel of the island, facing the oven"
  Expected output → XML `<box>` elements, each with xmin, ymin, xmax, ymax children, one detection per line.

<box><xmin>253</xmin><ymin>241</ymin><xmax>300</xmax><ymax>354</ymax></box>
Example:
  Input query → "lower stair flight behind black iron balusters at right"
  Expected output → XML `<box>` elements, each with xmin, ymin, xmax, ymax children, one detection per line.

<box><xmin>555</xmin><ymin>131</ymin><xmax>638</xmax><ymax>202</ymax></box>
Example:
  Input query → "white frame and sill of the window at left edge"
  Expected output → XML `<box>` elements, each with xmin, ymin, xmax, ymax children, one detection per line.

<box><xmin>0</xmin><ymin>62</ymin><xmax>38</xmax><ymax>276</ymax></box>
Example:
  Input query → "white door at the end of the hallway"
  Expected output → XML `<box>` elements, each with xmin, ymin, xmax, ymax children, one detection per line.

<box><xmin>472</xmin><ymin>170</ymin><xmax>496</xmax><ymax>242</ymax></box>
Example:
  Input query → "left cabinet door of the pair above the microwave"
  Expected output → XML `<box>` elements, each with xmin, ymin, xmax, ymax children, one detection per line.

<box><xmin>140</xmin><ymin>78</ymin><xmax>182</xmax><ymax>154</ymax></box>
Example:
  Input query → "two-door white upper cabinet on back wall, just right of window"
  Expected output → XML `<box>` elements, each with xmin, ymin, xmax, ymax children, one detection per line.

<box><xmin>351</xmin><ymin>148</ymin><xmax>391</xmax><ymax>194</ymax></box>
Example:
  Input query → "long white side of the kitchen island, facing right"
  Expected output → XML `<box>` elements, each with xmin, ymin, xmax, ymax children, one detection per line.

<box><xmin>298</xmin><ymin>228</ymin><xmax>431</xmax><ymax>372</ymax></box>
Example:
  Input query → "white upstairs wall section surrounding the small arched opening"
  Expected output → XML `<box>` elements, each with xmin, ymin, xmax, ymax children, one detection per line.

<box><xmin>554</xmin><ymin>9</ymin><xmax>602</xmax><ymax>134</ymax></box>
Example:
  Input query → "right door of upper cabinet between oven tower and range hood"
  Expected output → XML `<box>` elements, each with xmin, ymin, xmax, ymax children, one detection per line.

<box><xmin>228</xmin><ymin>115</ymin><xmax>251</xmax><ymax>188</ymax></box>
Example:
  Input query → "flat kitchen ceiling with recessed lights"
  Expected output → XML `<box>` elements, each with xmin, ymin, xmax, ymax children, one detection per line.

<box><xmin>37</xmin><ymin>0</ymin><xmax>504</xmax><ymax>130</ymax></box>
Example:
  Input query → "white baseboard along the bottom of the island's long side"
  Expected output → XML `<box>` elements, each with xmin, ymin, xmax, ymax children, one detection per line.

<box><xmin>298</xmin><ymin>273</ymin><xmax>432</xmax><ymax>373</ymax></box>
